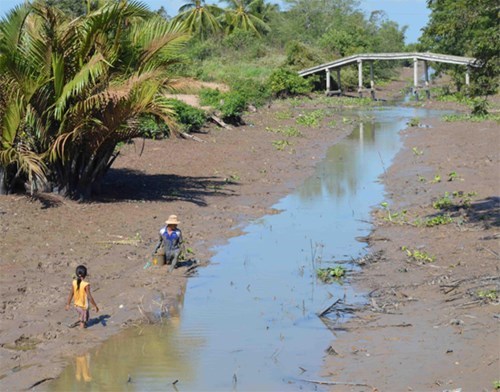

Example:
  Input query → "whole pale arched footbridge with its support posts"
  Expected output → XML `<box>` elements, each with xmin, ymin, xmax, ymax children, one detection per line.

<box><xmin>299</xmin><ymin>53</ymin><xmax>480</xmax><ymax>98</ymax></box>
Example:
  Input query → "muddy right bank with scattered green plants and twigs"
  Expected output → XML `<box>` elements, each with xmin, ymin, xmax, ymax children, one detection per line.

<box><xmin>324</xmin><ymin>109</ymin><xmax>500</xmax><ymax>391</ymax></box>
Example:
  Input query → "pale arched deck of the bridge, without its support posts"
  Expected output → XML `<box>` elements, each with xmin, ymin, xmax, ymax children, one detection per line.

<box><xmin>299</xmin><ymin>52</ymin><xmax>479</xmax><ymax>76</ymax></box>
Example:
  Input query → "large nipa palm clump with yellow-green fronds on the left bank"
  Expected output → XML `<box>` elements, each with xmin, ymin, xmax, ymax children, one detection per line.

<box><xmin>0</xmin><ymin>0</ymin><xmax>189</xmax><ymax>199</ymax></box>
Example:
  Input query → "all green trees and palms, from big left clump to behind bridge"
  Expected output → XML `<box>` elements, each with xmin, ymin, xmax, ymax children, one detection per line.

<box><xmin>0</xmin><ymin>0</ymin><xmax>499</xmax><ymax>200</ymax></box>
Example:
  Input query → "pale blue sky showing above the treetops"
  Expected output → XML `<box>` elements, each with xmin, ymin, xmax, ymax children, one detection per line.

<box><xmin>0</xmin><ymin>0</ymin><xmax>429</xmax><ymax>44</ymax></box>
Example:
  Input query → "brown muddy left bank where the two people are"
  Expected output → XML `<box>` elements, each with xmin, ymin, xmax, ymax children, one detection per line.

<box><xmin>0</xmin><ymin>95</ymin><xmax>358</xmax><ymax>390</ymax></box>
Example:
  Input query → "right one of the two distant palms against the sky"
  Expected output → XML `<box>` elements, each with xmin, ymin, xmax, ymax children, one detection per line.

<box><xmin>221</xmin><ymin>0</ymin><xmax>270</xmax><ymax>36</ymax></box>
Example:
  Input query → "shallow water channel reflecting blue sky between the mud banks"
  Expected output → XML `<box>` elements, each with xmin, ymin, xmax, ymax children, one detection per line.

<box><xmin>49</xmin><ymin>107</ymin><xmax>443</xmax><ymax>391</ymax></box>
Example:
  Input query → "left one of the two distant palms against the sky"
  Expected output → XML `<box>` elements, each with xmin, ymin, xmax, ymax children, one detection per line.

<box><xmin>174</xmin><ymin>0</ymin><xmax>222</xmax><ymax>38</ymax></box>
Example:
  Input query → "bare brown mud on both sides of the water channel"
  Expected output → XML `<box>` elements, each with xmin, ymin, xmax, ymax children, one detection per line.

<box><xmin>0</xmin><ymin>72</ymin><xmax>500</xmax><ymax>391</ymax></box>
